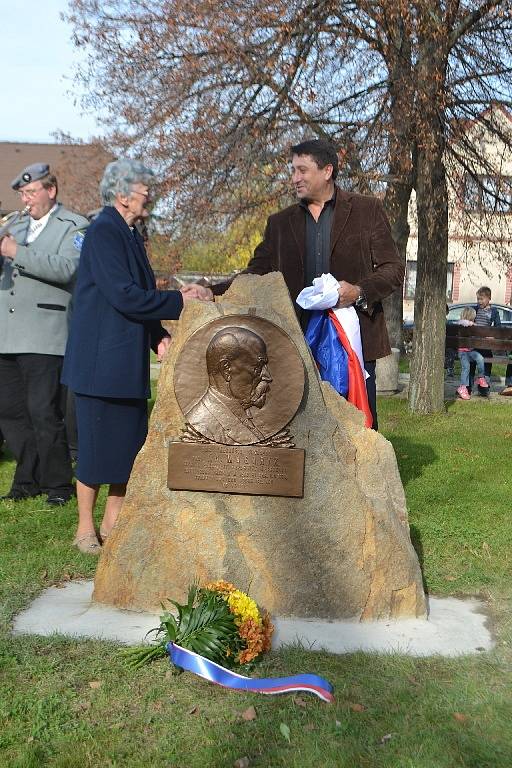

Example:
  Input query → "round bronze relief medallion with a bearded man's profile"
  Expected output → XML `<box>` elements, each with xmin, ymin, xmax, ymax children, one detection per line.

<box><xmin>174</xmin><ymin>315</ymin><xmax>304</xmax><ymax>445</ymax></box>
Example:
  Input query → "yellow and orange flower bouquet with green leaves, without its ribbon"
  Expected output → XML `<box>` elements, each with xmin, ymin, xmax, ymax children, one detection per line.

<box><xmin>121</xmin><ymin>581</ymin><xmax>274</xmax><ymax>670</ymax></box>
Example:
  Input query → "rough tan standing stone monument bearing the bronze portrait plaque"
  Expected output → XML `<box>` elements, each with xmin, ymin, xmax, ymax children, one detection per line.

<box><xmin>94</xmin><ymin>273</ymin><xmax>426</xmax><ymax>620</ymax></box>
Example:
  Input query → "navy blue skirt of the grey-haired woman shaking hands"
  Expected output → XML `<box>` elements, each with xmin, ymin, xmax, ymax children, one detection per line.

<box><xmin>75</xmin><ymin>394</ymin><xmax>148</xmax><ymax>485</ymax></box>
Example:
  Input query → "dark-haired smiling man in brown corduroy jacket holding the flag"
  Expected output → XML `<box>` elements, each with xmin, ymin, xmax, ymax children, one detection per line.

<box><xmin>184</xmin><ymin>139</ymin><xmax>404</xmax><ymax>429</ymax></box>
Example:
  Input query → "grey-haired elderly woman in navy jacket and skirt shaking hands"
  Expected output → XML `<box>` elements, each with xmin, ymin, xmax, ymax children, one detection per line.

<box><xmin>62</xmin><ymin>160</ymin><xmax>199</xmax><ymax>554</ymax></box>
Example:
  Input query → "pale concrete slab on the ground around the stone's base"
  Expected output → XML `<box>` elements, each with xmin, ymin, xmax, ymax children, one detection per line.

<box><xmin>13</xmin><ymin>581</ymin><xmax>493</xmax><ymax>656</ymax></box>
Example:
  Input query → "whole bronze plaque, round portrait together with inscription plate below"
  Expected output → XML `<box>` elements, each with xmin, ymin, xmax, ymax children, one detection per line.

<box><xmin>167</xmin><ymin>315</ymin><xmax>304</xmax><ymax>497</ymax></box>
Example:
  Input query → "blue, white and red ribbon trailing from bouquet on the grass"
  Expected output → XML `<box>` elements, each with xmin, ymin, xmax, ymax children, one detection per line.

<box><xmin>166</xmin><ymin>643</ymin><xmax>334</xmax><ymax>703</ymax></box>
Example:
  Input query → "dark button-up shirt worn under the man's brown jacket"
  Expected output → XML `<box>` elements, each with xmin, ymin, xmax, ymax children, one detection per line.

<box><xmin>299</xmin><ymin>189</ymin><xmax>336</xmax><ymax>330</ymax></box>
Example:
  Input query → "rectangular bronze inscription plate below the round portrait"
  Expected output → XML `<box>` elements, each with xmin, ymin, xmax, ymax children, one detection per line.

<box><xmin>167</xmin><ymin>443</ymin><xmax>305</xmax><ymax>497</ymax></box>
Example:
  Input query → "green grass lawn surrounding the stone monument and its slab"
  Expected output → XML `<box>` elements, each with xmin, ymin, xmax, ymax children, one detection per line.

<box><xmin>0</xmin><ymin>398</ymin><xmax>512</xmax><ymax>768</ymax></box>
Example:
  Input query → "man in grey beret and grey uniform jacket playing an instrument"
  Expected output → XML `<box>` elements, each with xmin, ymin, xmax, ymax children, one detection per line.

<box><xmin>0</xmin><ymin>163</ymin><xmax>88</xmax><ymax>506</ymax></box>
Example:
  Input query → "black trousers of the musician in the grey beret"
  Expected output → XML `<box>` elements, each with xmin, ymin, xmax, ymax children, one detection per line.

<box><xmin>0</xmin><ymin>354</ymin><xmax>72</xmax><ymax>495</ymax></box>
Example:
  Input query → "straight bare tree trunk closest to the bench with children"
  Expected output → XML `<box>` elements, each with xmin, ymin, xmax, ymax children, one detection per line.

<box><xmin>409</xmin><ymin>38</ymin><xmax>448</xmax><ymax>413</ymax></box>
